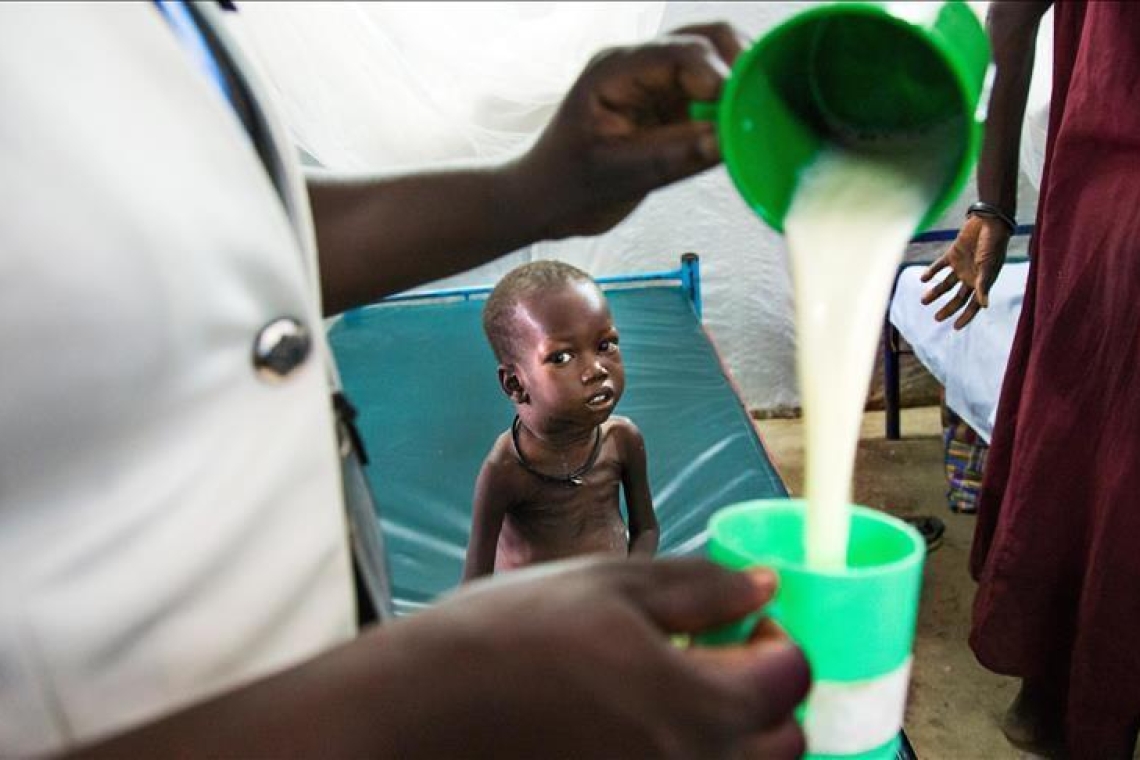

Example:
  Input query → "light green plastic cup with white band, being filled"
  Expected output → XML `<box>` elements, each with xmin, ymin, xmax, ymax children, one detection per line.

<box><xmin>700</xmin><ymin>499</ymin><xmax>926</xmax><ymax>760</ymax></box>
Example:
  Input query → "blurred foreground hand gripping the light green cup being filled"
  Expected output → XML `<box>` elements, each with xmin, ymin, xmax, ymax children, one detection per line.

<box><xmin>383</xmin><ymin>558</ymin><xmax>809</xmax><ymax>760</ymax></box>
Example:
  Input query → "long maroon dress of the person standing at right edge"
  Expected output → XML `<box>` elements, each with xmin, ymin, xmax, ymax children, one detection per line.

<box><xmin>970</xmin><ymin>2</ymin><xmax>1140</xmax><ymax>758</ymax></box>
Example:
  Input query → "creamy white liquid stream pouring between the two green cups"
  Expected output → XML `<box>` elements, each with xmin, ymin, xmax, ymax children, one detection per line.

<box><xmin>784</xmin><ymin>142</ymin><xmax>944</xmax><ymax>569</ymax></box>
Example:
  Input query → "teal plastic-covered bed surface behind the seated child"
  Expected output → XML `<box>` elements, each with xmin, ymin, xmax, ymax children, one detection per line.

<box><xmin>329</xmin><ymin>262</ymin><xmax>787</xmax><ymax>612</ymax></box>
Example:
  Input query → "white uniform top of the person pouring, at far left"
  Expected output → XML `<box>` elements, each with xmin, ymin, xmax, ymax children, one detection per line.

<box><xmin>0</xmin><ymin>3</ymin><xmax>355</xmax><ymax>757</ymax></box>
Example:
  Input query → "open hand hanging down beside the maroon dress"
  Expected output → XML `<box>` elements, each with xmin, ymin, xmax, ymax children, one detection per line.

<box><xmin>922</xmin><ymin>216</ymin><xmax>1011</xmax><ymax>329</ymax></box>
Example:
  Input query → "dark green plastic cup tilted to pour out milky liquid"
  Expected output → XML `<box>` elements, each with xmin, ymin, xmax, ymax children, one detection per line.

<box><xmin>692</xmin><ymin>0</ymin><xmax>992</xmax><ymax>232</ymax></box>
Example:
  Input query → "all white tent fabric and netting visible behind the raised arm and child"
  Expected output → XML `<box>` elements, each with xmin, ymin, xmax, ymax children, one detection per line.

<box><xmin>229</xmin><ymin>2</ymin><xmax>1036</xmax><ymax>409</ymax></box>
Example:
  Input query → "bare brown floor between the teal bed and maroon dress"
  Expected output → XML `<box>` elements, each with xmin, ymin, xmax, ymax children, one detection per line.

<box><xmin>756</xmin><ymin>407</ymin><xmax>1033</xmax><ymax>760</ymax></box>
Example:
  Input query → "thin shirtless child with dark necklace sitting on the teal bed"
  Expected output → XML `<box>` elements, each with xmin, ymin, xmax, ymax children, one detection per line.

<box><xmin>463</xmin><ymin>261</ymin><xmax>659</xmax><ymax>580</ymax></box>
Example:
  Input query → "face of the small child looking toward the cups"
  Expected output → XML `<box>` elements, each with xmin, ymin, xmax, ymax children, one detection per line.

<box><xmin>514</xmin><ymin>283</ymin><xmax>626</xmax><ymax>426</ymax></box>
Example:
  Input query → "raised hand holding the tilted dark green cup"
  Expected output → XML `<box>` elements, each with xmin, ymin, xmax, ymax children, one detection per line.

<box><xmin>519</xmin><ymin>23</ymin><xmax>748</xmax><ymax>239</ymax></box>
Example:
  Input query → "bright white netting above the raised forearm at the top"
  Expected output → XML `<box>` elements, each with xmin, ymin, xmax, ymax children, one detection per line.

<box><xmin>233</xmin><ymin>2</ymin><xmax>665</xmax><ymax>170</ymax></box>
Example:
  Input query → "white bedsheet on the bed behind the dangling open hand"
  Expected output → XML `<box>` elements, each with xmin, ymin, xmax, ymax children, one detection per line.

<box><xmin>890</xmin><ymin>262</ymin><xmax>1029</xmax><ymax>443</ymax></box>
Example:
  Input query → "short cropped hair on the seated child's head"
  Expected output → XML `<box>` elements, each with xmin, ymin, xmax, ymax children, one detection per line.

<box><xmin>483</xmin><ymin>260</ymin><xmax>596</xmax><ymax>363</ymax></box>
